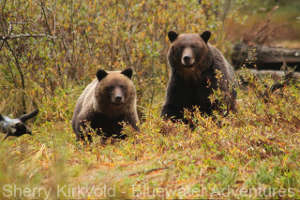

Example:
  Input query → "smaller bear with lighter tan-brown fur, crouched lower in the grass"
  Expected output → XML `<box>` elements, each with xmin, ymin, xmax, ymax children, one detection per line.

<box><xmin>72</xmin><ymin>68</ymin><xmax>139</xmax><ymax>142</ymax></box>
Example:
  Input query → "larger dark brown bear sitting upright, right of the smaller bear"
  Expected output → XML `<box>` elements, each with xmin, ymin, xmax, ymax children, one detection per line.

<box><xmin>161</xmin><ymin>31</ymin><xmax>236</xmax><ymax>120</ymax></box>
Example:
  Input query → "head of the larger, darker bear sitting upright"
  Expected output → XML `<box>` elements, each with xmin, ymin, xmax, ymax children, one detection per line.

<box><xmin>168</xmin><ymin>31</ymin><xmax>212</xmax><ymax>80</ymax></box>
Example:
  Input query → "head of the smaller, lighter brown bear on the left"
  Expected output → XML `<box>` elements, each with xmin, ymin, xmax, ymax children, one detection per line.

<box><xmin>95</xmin><ymin>68</ymin><xmax>136</xmax><ymax>108</ymax></box>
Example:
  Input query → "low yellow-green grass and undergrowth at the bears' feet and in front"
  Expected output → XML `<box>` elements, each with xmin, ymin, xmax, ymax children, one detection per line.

<box><xmin>0</xmin><ymin>68</ymin><xmax>300</xmax><ymax>199</ymax></box>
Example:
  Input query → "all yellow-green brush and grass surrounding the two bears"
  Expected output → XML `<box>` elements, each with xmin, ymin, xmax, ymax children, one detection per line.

<box><xmin>0</xmin><ymin>0</ymin><xmax>300</xmax><ymax>199</ymax></box>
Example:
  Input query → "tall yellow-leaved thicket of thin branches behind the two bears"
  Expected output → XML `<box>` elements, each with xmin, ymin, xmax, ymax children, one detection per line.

<box><xmin>0</xmin><ymin>0</ymin><xmax>248</xmax><ymax>114</ymax></box>
